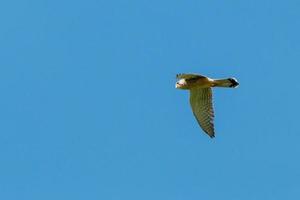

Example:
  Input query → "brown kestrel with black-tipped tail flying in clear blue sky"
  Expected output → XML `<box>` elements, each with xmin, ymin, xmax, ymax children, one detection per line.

<box><xmin>175</xmin><ymin>74</ymin><xmax>239</xmax><ymax>138</ymax></box>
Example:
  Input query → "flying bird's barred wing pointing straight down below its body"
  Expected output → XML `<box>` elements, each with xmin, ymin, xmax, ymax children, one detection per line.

<box><xmin>190</xmin><ymin>88</ymin><xmax>215</xmax><ymax>138</ymax></box>
